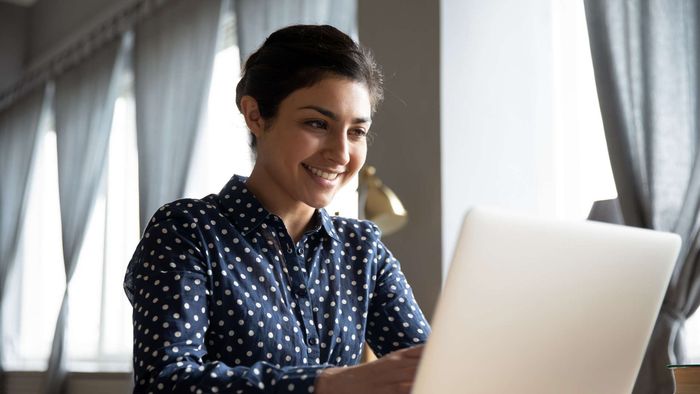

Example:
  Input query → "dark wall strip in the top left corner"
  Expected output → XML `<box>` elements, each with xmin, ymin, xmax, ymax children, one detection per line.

<box><xmin>0</xmin><ymin>3</ymin><xmax>28</xmax><ymax>92</ymax></box>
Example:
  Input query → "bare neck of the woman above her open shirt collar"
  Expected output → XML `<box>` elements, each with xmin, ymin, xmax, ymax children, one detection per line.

<box><xmin>246</xmin><ymin>169</ymin><xmax>315</xmax><ymax>243</ymax></box>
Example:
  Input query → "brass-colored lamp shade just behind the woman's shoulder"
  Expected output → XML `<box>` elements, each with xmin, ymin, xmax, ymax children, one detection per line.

<box><xmin>359</xmin><ymin>166</ymin><xmax>408</xmax><ymax>235</ymax></box>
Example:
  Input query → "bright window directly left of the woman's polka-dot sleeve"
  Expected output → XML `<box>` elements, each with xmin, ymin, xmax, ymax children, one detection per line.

<box><xmin>66</xmin><ymin>84</ymin><xmax>139</xmax><ymax>371</ymax></box>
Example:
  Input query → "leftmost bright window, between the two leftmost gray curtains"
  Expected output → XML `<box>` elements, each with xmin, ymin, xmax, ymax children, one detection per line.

<box><xmin>2</xmin><ymin>125</ymin><xmax>65</xmax><ymax>370</ymax></box>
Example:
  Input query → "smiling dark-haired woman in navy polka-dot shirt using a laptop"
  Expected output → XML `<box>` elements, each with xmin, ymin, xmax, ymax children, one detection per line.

<box><xmin>125</xmin><ymin>26</ymin><xmax>430</xmax><ymax>393</ymax></box>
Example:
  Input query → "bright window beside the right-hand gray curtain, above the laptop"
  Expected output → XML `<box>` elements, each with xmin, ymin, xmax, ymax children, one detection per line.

<box><xmin>551</xmin><ymin>1</ymin><xmax>617</xmax><ymax>219</ymax></box>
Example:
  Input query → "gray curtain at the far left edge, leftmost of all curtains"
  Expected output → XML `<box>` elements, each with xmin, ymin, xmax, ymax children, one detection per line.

<box><xmin>0</xmin><ymin>89</ymin><xmax>45</xmax><ymax>378</ymax></box>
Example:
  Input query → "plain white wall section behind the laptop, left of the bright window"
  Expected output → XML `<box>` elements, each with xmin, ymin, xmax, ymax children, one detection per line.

<box><xmin>440</xmin><ymin>0</ymin><xmax>552</xmax><ymax>278</ymax></box>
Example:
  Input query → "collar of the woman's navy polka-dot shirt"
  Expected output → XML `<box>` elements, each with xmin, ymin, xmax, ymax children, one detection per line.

<box><xmin>219</xmin><ymin>175</ymin><xmax>340</xmax><ymax>242</ymax></box>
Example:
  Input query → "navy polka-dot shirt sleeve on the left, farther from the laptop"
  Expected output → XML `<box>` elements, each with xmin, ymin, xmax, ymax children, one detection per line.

<box><xmin>125</xmin><ymin>206</ymin><xmax>326</xmax><ymax>393</ymax></box>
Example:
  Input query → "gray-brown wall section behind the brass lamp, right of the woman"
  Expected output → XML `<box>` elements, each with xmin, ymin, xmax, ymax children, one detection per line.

<box><xmin>358</xmin><ymin>0</ymin><xmax>443</xmax><ymax>317</ymax></box>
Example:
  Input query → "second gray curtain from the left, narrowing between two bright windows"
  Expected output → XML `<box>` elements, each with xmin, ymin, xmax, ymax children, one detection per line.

<box><xmin>44</xmin><ymin>35</ymin><xmax>127</xmax><ymax>393</ymax></box>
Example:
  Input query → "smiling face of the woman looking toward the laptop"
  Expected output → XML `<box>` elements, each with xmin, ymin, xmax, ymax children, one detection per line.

<box><xmin>252</xmin><ymin>77</ymin><xmax>371</xmax><ymax>208</ymax></box>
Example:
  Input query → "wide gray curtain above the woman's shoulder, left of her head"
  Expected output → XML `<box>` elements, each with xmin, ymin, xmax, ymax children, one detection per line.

<box><xmin>134</xmin><ymin>0</ymin><xmax>223</xmax><ymax>231</ymax></box>
